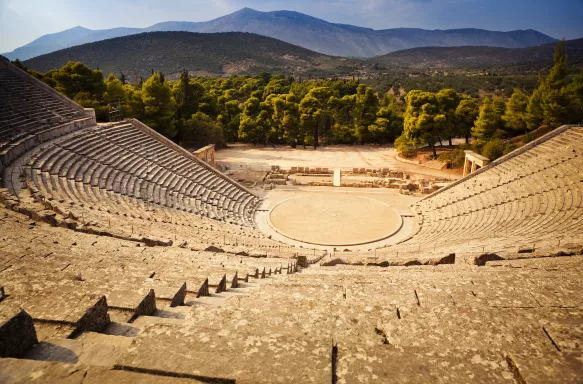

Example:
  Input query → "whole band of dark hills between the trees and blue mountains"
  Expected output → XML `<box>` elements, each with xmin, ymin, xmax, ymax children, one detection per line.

<box><xmin>24</xmin><ymin>32</ymin><xmax>583</xmax><ymax>78</ymax></box>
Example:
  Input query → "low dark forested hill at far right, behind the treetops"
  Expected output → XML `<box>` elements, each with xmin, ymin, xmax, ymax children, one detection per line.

<box><xmin>370</xmin><ymin>39</ymin><xmax>583</xmax><ymax>70</ymax></box>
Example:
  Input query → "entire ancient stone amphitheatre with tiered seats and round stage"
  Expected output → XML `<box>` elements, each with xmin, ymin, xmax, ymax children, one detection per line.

<box><xmin>0</xmin><ymin>52</ymin><xmax>583</xmax><ymax>383</ymax></box>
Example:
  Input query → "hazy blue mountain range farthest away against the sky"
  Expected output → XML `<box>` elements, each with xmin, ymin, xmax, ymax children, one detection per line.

<box><xmin>3</xmin><ymin>8</ymin><xmax>556</xmax><ymax>60</ymax></box>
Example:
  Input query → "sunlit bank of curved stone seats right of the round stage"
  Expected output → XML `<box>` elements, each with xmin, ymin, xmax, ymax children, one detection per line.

<box><xmin>415</xmin><ymin>129</ymin><xmax>583</xmax><ymax>249</ymax></box>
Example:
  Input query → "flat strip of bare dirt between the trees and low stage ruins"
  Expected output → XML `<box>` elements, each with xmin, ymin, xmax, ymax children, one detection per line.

<box><xmin>215</xmin><ymin>144</ymin><xmax>460</xmax><ymax>180</ymax></box>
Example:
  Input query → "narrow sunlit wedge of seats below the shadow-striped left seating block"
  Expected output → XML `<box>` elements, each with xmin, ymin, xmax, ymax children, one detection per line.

<box><xmin>24</xmin><ymin>173</ymin><xmax>311</xmax><ymax>257</ymax></box>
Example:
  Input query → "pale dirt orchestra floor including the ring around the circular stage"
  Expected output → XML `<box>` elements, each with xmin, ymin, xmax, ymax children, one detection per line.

<box><xmin>255</xmin><ymin>186</ymin><xmax>419</xmax><ymax>251</ymax></box>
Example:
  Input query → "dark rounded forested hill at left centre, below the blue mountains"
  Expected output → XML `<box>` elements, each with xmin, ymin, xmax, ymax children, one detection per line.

<box><xmin>25</xmin><ymin>32</ymin><xmax>360</xmax><ymax>77</ymax></box>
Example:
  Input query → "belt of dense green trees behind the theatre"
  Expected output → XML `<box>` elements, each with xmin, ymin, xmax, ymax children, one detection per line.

<box><xmin>15</xmin><ymin>42</ymin><xmax>583</xmax><ymax>165</ymax></box>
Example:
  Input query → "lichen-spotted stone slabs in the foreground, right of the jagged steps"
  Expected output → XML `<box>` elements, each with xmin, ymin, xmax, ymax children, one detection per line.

<box><xmin>117</xmin><ymin>260</ymin><xmax>583</xmax><ymax>383</ymax></box>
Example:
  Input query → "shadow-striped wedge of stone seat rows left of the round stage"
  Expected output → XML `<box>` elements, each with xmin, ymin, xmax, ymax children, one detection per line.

<box><xmin>20</xmin><ymin>124</ymin><xmax>259</xmax><ymax>226</ymax></box>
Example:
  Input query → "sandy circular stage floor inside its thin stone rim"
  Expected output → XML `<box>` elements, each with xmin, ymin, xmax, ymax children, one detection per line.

<box><xmin>268</xmin><ymin>193</ymin><xmax>403</xmax><ymax>246</ymax></box>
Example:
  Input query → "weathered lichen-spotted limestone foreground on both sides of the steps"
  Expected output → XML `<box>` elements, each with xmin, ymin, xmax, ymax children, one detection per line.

<box><xmin>0</xmin><ymin>210</ymin><xmax>583</xmax><ymax>383</ymax></box>
